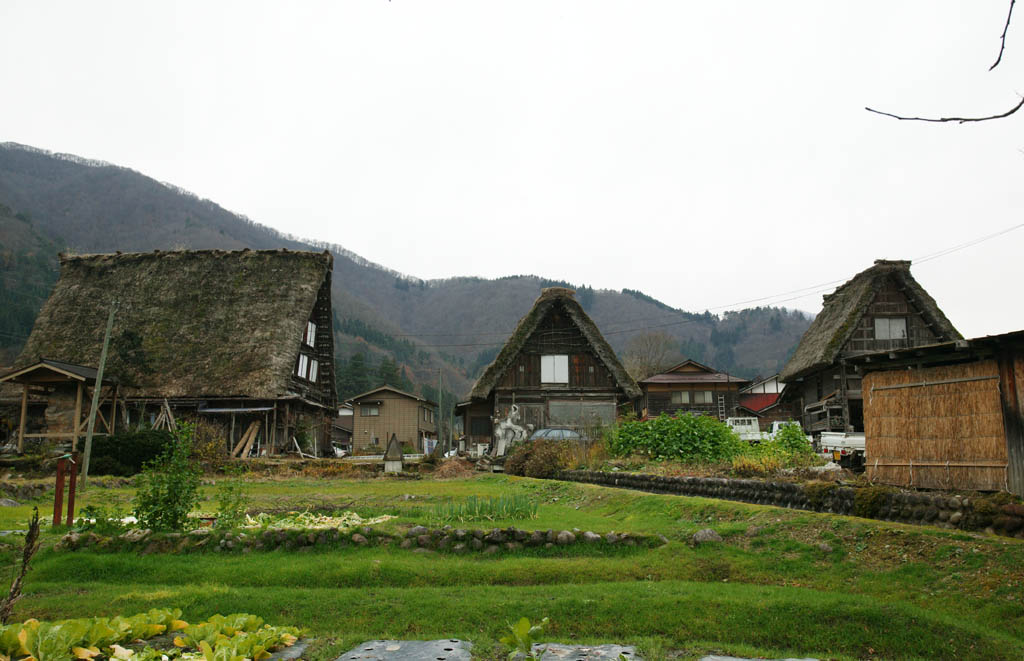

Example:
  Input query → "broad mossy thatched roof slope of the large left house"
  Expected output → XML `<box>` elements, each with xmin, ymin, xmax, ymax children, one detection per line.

<box><xmin>16</xmin><ymin>250</ymin><xmax>333</xmax><ymax>399</ymax></box>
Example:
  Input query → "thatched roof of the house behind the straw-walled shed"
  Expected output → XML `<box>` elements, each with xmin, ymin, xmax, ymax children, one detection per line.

<box><xmin>779</xmin><ymin>260</ymin><xmax>963</xmax><ymax>382</ymax></box>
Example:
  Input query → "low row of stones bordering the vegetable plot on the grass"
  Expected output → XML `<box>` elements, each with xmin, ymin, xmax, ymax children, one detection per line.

<box><xmin>55</xmin><ymin>526</ymin><xmax>655</xmax><ymax>554</ymax></box>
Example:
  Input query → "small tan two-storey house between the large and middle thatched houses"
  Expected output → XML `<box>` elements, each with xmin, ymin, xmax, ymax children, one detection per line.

<box><xmin>349</xmin><ymin>386</ymin><xmax>437</xmax><ymax>454</ymax></box>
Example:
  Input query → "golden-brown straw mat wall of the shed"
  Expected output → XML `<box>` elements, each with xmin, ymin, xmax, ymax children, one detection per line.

<box><xmin>863</xmin><ymin>360</ymin><xmax>1007</xmax><ymax>491</ymax></box>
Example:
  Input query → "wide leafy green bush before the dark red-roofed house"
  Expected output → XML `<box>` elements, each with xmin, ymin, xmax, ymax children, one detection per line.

<box><xmin>608</xmin><ymin>413</ymin><xmax>749</xmax><ymax>464</ymax></box>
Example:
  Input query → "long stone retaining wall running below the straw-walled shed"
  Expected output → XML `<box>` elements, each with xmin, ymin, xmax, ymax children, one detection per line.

<box><xmin>557</xmin><ymin>471</ymin><xmax>1024</xmax><ymax>539</ymax></box>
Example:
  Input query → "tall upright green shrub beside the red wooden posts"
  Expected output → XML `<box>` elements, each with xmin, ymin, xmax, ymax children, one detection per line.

<box><xmin>132</xmin><ymin>423</ymin><xmax>200</xmax><ymax>530</ymax></box>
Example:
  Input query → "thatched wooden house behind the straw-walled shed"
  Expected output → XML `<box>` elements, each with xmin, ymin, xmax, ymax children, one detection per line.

<box><xmin>779</xmin><ymin>260</ymin><xmax>963</xmax><ymax>435</ymax></box>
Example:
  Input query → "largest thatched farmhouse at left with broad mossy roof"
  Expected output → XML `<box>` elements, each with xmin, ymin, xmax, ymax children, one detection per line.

<box><xmin>4</xmin><ymin>250</ymin><xmax>337</xmax><ymax>454</ymax></box>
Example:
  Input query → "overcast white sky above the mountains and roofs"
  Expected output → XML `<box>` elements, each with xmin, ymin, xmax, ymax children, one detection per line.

<box><xmin>0</xmin><ymin>0</ymin><xmax>1024</xmax><ymax>337</ymax></box>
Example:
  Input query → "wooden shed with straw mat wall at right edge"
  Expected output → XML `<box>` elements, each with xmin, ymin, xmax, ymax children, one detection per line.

<box><xmin>852</xmin><ymin>332</ymin><xmax>1024</xmax><ymax>495</ymax></box>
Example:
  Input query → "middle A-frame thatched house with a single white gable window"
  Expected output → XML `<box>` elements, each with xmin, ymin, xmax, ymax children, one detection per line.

<box><xmin>456</xmin><ymin>288</ymin><xmax>641</xmax><ymax>452</ymax></box>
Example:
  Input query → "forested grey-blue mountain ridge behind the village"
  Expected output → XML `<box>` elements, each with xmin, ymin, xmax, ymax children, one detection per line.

<box><xmin>0</xmin><ymin>142</ymin><xmax>810</xmax><ymax>398</ymax></box>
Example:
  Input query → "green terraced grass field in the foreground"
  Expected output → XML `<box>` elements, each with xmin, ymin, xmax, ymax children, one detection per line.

<box><xmin>0</xmin><ymin>475</ymin><xmax>1024</xmax><ymax>660</ymax></box>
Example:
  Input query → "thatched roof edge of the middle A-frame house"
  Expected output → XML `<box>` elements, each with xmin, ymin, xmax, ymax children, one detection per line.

<box><xmin>469</xmin><ymin>287</ymin><xmax>643</xmax><ymax>399</ymax></box>
